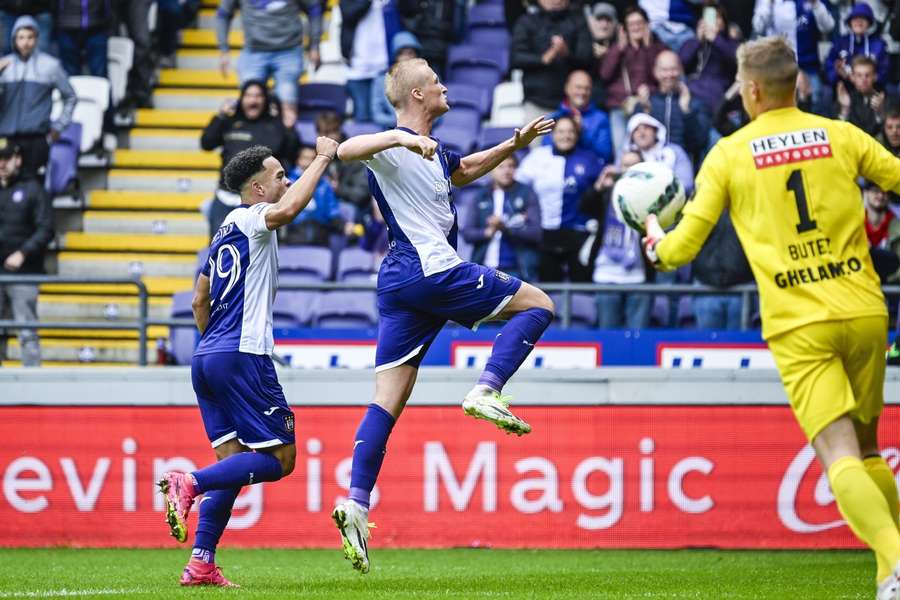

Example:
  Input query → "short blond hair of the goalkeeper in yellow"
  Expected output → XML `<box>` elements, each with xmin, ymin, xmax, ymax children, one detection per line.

<box><xmin>737</xmin><ymin>36</ymin><xmax>799</xmax><ymax>99</ymax></box>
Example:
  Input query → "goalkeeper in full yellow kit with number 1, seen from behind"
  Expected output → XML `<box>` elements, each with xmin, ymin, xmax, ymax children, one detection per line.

<box><xmin>644</xmin><ymin>38</ymin><xmax>900</xmax><ymax>600</ymax></box>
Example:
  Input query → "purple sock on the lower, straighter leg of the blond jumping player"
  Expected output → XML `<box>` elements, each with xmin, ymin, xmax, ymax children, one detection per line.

<box><xmin>349</xmin><ymin>404</ymin><xmax>394</xmax><ymax>509</ymax></box>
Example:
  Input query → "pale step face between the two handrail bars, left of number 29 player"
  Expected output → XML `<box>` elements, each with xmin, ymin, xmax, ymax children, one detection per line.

<box><xmin>38</xmin><ymin>293</ymin><xmax>172</xmax><ymax>321</ymax></box>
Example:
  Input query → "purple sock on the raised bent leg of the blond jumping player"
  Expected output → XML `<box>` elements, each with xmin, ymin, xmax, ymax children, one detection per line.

<box><xmin>478</xmin><ymin>308</ymin><xmax>553</xmax><ymax>392</ymax></box>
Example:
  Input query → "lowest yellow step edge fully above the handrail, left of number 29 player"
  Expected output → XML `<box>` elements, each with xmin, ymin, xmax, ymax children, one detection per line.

<box><xmin>60</xmin><ymin>231</ymin><xmax>209</xmax><ymax>256</ymax></box>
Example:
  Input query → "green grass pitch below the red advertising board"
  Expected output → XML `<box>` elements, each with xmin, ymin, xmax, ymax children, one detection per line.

<box><xmin>0</xmin><ymin>548</ymin><xmax>875</xmax><ymax>600</ymax></box>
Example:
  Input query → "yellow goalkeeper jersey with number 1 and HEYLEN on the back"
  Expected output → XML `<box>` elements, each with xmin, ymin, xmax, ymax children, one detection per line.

<box><xmin>656</xmin><ymin>108</ymin><xmax>900</xmax><ymax>339</ymax></box>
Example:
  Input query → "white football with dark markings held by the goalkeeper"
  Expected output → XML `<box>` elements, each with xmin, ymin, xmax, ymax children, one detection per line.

<box><xmin>612</xmin><ymin>162</ymin><xmax>685</xmax><ymax>234</ymax></box>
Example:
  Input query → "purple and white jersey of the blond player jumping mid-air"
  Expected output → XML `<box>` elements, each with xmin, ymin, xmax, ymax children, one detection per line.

<box><xmin>364</xmin><ymin>127</ymin><xmax>463</xmax><ymax>290</ymax></box>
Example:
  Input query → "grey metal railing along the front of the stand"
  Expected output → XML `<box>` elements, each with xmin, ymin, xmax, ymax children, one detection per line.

<box><xmin>0</xmin><ymin>275</ymin><xmax>900</xmax><ymax>366</ymax></box>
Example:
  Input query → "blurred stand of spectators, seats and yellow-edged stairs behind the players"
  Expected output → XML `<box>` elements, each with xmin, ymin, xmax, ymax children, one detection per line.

<box><xmin>0</xmin><ymin>0</ymin><xmax>900</xmax><ymax>364</ymax></box>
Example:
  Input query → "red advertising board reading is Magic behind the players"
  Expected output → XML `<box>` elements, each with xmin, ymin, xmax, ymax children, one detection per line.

<box><xmin>0</xmin><ymin>406</ymin><xmax>900</xmax><ymax>548</ymax></box>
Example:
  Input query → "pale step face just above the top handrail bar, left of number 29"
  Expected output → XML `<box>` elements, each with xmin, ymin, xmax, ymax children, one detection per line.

<box><xmin>56</xmin><ymin>252</ymin><xmax>197</xmax><ymax>279</ymax></box>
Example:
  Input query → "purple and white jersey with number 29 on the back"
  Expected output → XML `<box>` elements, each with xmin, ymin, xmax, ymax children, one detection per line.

<box><xmin>194</xmin><ymin>203</ymin><xmax>278</xmax><ymax>356</ymax></box>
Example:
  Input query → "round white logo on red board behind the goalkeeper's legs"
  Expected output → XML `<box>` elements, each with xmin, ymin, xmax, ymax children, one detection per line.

<box><xmin>778</xmin><ymin>444</ymin><xmax>900</xmax><ymax>533</ymax></box>
